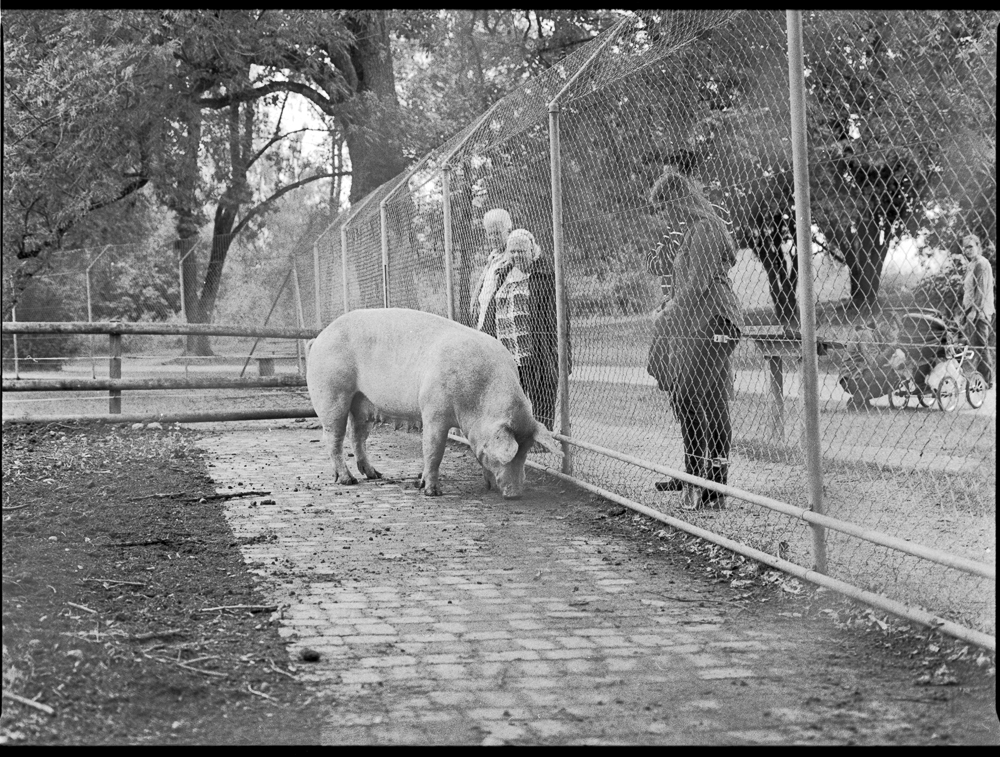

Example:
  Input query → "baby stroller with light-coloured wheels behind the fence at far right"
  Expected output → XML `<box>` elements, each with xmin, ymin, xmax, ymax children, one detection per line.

<box><xmin>889</xmin><ymin>309</ymin><xmax>986</xmax><ymax>412</ymax></box>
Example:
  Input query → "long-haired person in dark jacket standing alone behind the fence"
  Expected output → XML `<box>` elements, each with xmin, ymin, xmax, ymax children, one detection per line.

<box><xmin>647</xmin><ymin>168</ymin><xmax>743</xmax><ymax>510</ymax></box>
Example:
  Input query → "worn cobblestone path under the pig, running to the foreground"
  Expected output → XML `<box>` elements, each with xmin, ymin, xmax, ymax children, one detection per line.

<box><xmin>201</xmin><ymin>423</ymin><xmax>996</xmax><ymax>744</ymax></box>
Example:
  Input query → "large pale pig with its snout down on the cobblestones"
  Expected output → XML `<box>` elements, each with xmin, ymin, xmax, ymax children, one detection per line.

<box><xmin>306</xmin><ymin>308</ymin><xmax>561</xmax><ymax>499</ymax></box>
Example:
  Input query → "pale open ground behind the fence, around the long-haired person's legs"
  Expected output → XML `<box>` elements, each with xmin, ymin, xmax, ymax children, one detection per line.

<box><xmin>570</xmin><ymin>382</ymin><xmax>996</xmax><ymax>631</ymax></box>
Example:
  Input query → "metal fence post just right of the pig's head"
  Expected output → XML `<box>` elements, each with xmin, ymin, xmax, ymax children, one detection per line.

<box><xmin>549</xmin><ymin>100</ymin><xmax>573</xmax><ymax>474</ymax></box>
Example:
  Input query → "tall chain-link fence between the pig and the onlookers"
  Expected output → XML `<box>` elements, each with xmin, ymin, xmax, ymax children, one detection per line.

<box><xmin>292</xmin><ymin>11</ymin><xmax>997</xmax><ymax>633</ymax></box>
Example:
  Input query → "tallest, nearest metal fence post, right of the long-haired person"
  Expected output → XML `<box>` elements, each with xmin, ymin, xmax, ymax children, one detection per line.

<box><xmin>785</xmin><ymin>11</ymin><xmax>826</xmax><ymax>573</ymax></box>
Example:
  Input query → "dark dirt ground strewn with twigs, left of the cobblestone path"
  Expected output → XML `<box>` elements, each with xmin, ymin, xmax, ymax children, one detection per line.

<box><xmin>0</xmin><ymin>425</ymin><xmax>318</xmax><ymax>744</ymax></box>
